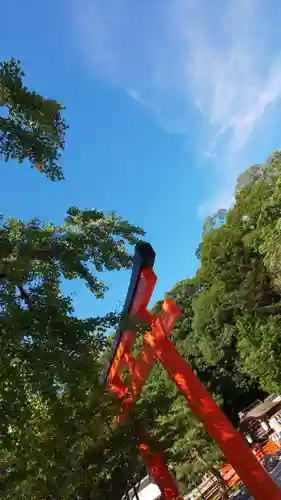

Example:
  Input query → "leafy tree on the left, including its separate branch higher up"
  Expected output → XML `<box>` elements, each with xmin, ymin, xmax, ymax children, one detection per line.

<box><xmin>0</xmin><ymin>60</ymin><xmax>147</xmax><ymax>500</ymax></box>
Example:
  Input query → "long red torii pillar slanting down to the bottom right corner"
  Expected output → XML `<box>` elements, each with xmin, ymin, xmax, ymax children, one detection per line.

<box><xmin>144</xmin><ymin>301</ymin><xmax>281</xmax><ymax>500</ymax></box>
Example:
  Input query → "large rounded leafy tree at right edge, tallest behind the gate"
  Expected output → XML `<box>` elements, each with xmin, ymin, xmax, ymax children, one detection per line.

<box><xmin>193</xmin><ymin>152</ymin><xmax>281</xmax><ymax>392</ymax></box>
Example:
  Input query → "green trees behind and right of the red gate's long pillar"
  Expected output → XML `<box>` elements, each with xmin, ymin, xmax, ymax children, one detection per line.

<box><xmin>134</xmin><ymin>152</ymin><xmax>281</xmax><ymax>489</ymax></box>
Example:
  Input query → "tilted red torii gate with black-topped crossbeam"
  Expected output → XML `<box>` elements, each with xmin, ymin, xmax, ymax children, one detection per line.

<box><xmin>104</xmin><ymin>243</ymin><xmax>281</xmax><ymax>500</ymax></box>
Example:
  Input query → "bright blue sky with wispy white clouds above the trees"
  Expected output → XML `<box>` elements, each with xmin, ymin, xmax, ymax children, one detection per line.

<box><xmin>0</xmin><ymin>0</ymin><xmax>281</xmax><ymax>315</ymax></box>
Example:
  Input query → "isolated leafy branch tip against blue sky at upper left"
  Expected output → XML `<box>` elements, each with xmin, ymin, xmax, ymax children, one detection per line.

<box><xmin>0</xmin><ymin>59</ymin><xmax>67</xmax><ymax>181</ymax></box>
